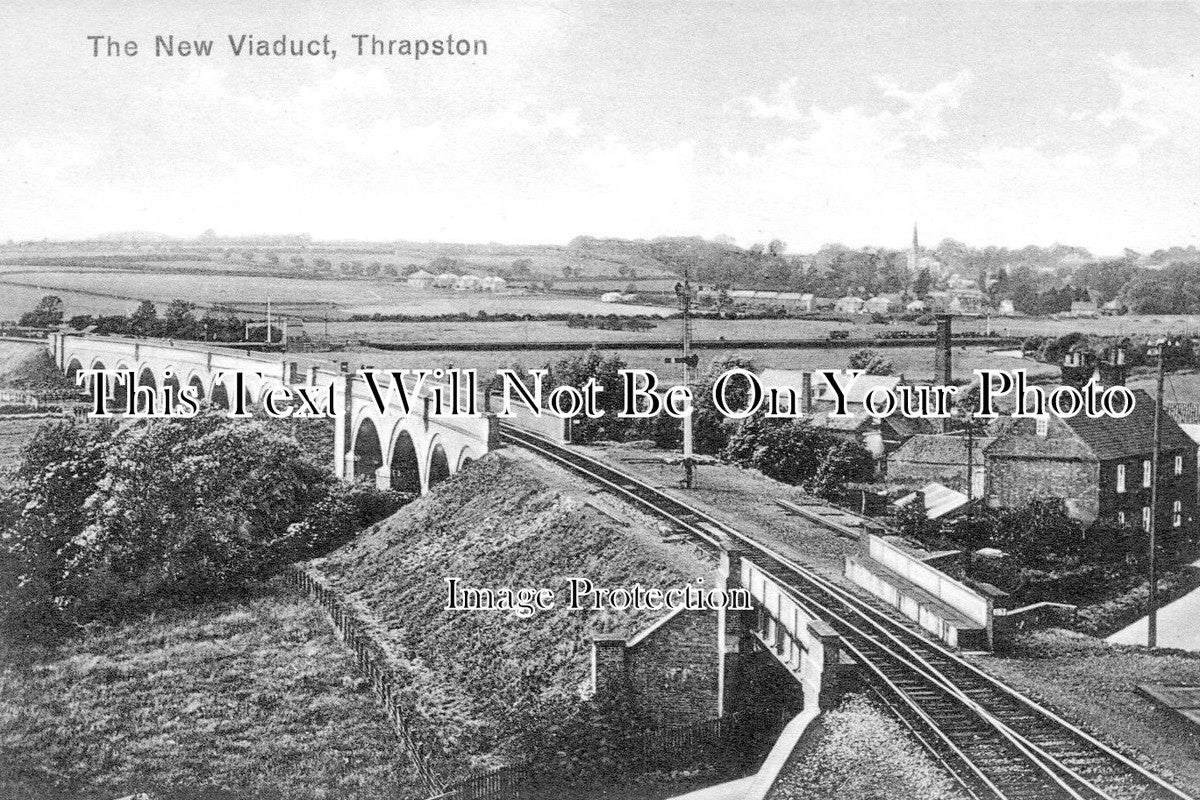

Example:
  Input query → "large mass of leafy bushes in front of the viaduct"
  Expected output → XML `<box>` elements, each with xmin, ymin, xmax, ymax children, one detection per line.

<box><xmin>0</xmin><ymin>414</ymin><xmax>408</xmax><ymax>630</ymax></box>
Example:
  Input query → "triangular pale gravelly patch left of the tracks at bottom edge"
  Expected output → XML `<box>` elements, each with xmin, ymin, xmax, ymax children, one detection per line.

<box><xmin>767</xmin><ymin>696</ymin><xmax>962</xmax><ymax>800</ymax></box>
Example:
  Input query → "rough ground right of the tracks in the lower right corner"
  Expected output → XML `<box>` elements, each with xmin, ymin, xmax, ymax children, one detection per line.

<box><xmin>972</xmin><ymin>630</ymin><xmax>1200</xmax><ymax>795</ymax></box>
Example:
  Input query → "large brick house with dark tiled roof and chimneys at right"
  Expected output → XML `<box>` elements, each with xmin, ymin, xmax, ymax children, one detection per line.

<box><xmin>984</xmin><ymin>390</ymin><xmax>1196</xmax><ymax>545</ymax></box>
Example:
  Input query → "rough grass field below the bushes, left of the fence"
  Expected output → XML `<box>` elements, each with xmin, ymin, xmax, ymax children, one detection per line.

<box><xmin>0</xmin><ymin>587</ymin><xmax>425</xmax><ymax>800</ymax></box>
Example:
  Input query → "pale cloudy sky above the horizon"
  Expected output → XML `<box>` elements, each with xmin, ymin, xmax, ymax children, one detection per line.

<box><xmin>0</xmin><ymin>0</ymin><xmax>1200</xmax><ymax>254</ymax></box>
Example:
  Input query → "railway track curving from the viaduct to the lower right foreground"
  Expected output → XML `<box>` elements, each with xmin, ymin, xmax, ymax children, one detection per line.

<box><xmin>500</xmin><ymin>425</ymin><xmax>1193</xmax><ymax>800</ymax></box>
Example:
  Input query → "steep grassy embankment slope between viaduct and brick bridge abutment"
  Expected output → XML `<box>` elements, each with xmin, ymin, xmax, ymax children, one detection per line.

<box><xmin>313</xmin><ymin>451</ymin><xmax>714</xmax><ymax>772</ymax></box>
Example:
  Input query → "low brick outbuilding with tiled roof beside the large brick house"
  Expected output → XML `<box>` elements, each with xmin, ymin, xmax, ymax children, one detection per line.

<box><xmin>888</xmin><ymin>434</ymin><xmax>992</xmax><ymax>498</ymax></box>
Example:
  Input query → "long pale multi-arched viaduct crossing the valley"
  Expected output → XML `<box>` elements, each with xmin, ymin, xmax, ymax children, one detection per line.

<box><xmin>50</xmin><ymin>333</ymin><xmax>498</xmax><ymax>493</ymax></box>
